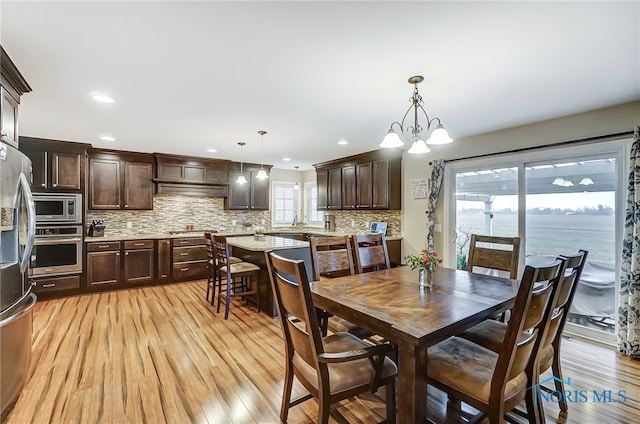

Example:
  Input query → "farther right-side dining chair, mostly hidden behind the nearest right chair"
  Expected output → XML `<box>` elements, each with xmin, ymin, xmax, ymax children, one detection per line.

<box><xmin>460</xmin><ymin>250</ymin><xmax>589</xmax><ymax>422</ymax></box>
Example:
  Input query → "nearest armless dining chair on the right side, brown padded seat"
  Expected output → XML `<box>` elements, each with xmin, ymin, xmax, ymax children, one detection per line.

<box><xmin>427</xmin><ymin>260</ymin><xmax>564</xmax><ymax>423</ymax></box>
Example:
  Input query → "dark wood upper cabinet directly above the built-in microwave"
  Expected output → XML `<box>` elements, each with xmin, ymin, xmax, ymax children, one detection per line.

<box><xmin>20</xmin><ymin>137</ymin><xmax>91</xmax><ymax>192</ymax></box>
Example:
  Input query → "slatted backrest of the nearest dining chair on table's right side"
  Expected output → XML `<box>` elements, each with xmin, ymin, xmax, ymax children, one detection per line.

<box><xmin>490</xmin><ymin>260</ymin><xmax>565</xmax><ymax>399</ymax></box>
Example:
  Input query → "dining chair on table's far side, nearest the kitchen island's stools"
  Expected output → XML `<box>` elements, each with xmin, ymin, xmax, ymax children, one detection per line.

<box><xmin>309</xmin><ymin>236</ymin><xmax>373</xmax><ymax>339</ymax></box>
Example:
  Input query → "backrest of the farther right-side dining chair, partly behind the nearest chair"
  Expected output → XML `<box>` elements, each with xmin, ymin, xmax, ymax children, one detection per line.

<box><xmin>543</xmin><ymin>250</ymin><xmax>589</xmax><ymax>348</ymax></box>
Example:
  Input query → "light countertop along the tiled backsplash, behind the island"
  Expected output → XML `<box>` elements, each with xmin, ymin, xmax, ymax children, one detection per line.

<box><xmin>84</xmin><ymin>227</ymin><xmax>402</xmax><ymax>243</ymax></box>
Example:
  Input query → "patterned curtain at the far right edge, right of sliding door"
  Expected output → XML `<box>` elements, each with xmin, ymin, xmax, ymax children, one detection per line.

<box><xmin>618</xmin><ymin>126</ymin><xmax>640</xmax><ymax>359</ymax></box>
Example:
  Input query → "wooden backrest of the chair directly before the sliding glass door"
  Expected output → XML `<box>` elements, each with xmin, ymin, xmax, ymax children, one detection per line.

<box><xmin>467</xmin><ymin>234</ymin><xmax>520</xmax><ymax>279</ymax></box>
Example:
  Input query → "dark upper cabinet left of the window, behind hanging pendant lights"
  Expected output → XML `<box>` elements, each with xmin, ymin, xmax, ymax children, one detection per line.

<box><xmin>224</xmin><ymin>163</ymin><xmax>271</xmax><ymax>211</ymax></box>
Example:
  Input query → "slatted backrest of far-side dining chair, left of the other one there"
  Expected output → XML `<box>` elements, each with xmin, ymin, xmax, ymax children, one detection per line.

<box><xmin>309</xmin><ymin>236</ymin><xmax>355</xmax><ymax>281</ymax></box>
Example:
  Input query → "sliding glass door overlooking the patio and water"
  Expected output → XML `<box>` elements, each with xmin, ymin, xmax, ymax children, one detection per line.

<box><xmin>445</xmin><ymin>141</ymin><xmax>628</xmax><ymax>341</ymax></box>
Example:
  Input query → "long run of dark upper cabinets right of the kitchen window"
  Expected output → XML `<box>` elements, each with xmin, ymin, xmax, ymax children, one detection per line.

<box><xmin>314</xmin><ymin>149</ymin><xmax>402</xmax><ymax>210</ymax></box>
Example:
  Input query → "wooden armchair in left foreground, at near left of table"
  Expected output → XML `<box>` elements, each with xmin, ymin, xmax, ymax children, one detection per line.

<box><xmin>266</xmin><ymin>252</ymin><xmax>397</xmax><ymax>423</ymax></box>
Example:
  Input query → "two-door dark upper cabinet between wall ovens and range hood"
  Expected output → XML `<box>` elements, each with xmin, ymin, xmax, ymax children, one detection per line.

<box><xmin>89</xmin><ymin>150</ymin><xmax>154</xmax><ymax>210</ymax></box>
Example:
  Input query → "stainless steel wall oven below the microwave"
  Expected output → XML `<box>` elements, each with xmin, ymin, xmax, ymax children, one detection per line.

<box><xmin>29</xmin><ymin>225</ymin><xmax>82</xmax><ymax>278</ymax></box>
